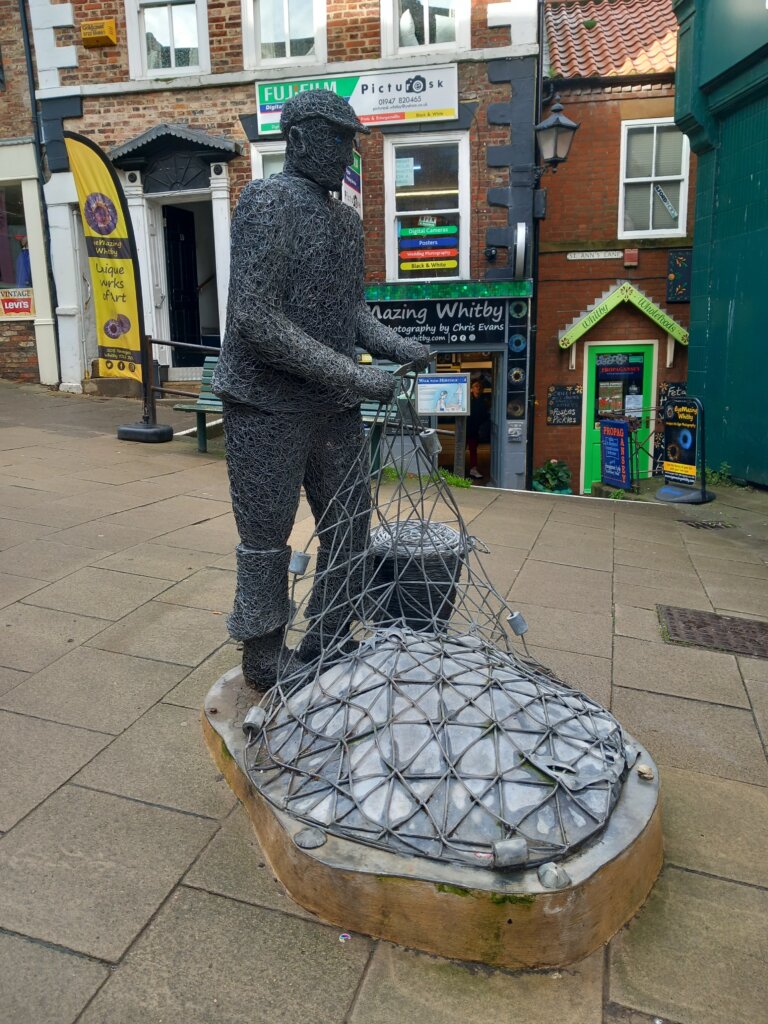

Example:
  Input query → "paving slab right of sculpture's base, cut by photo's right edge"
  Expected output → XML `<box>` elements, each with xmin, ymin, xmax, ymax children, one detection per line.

<box><xmin>662</xmin><ymin>768</ymin><xmax>768</xmax><ymax>887</ymax></box>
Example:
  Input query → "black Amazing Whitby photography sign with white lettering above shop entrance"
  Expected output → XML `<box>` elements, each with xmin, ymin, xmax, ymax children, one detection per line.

<box><xmin>370</xmin><ymin>298</ymin><xmax>508</xmax><ymax>351</ymax></box>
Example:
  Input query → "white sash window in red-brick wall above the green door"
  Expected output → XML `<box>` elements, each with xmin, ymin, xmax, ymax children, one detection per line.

<box><xmin>618</xmin><ymin>118</ymin><xmax>689</xmax><ymax>239</ymax></box>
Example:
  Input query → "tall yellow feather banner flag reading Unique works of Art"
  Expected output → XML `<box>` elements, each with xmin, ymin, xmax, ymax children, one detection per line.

<box><xmin>65</xmin><ymin>131</ymin><xmax>144</xmax><ymax>381</ymax></box>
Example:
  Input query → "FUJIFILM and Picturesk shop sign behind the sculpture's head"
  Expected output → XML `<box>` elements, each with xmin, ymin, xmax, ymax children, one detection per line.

<box><xmin>256</xmin><ymin>65</ymin><xmax>459</xmax><ymax>136</ymax></box>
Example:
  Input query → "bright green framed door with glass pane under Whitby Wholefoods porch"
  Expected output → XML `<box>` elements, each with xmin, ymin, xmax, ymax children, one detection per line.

<box><xmin>584</xmin><ymin>344</ymin><xmax>654</xmax><ymax>494</ymax></box>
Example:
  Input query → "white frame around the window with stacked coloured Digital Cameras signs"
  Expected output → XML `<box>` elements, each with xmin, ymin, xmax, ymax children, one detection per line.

<box><xmin>384</xmin><ymin>131</ymin><xmax>472</xmax><ymax>285</ymax></box>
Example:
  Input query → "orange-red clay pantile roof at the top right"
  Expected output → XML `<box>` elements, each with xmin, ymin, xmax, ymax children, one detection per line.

<box><xmin>545</xmin><ymin>0</ymin><xmax>677</xmax><ymax>78</ymax></box>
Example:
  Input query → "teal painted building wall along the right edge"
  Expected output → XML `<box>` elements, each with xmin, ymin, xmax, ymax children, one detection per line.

<box><xmin>676</xmin><ymin>0</ymin><xmax>768</xmax><ymax>485</ymax></box>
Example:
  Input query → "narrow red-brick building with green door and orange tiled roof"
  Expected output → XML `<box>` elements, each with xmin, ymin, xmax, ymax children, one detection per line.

<box><xmin>534</xmin><ymin>0</ymin><xmax>695</xmax><ymax>493</ymax></box>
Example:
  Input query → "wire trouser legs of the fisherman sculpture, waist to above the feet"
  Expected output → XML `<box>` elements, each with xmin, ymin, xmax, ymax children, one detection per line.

<box><xmin>224</xmin><ymin>402</ymin><xmax>371</xmax><ymax>640</ymax></box>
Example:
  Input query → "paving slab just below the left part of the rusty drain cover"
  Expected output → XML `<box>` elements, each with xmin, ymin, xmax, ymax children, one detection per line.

<box><xmin>613</xmin><ymin>637</ymin><xmax>750</xmax><ymax>708</ymax></box>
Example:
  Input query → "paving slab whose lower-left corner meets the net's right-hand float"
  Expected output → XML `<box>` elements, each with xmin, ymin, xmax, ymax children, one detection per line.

<box><xmin>511</xmin><ymin>558</ymin><xmax>611</xmax><ymax>612</ymax></box>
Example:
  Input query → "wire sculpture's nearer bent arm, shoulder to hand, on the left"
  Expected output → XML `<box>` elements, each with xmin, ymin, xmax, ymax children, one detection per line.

<box><xmin>227</xmin><ymin>183</ymin><xmax>395</xmax><ymax>406</ymax></box>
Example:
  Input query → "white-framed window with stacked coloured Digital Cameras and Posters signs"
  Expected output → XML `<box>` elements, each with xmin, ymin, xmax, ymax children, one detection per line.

<box><xmin>385</xmin><ymin>133</ymin><xmax>469</xmax><ymax>281</ymax></box>
